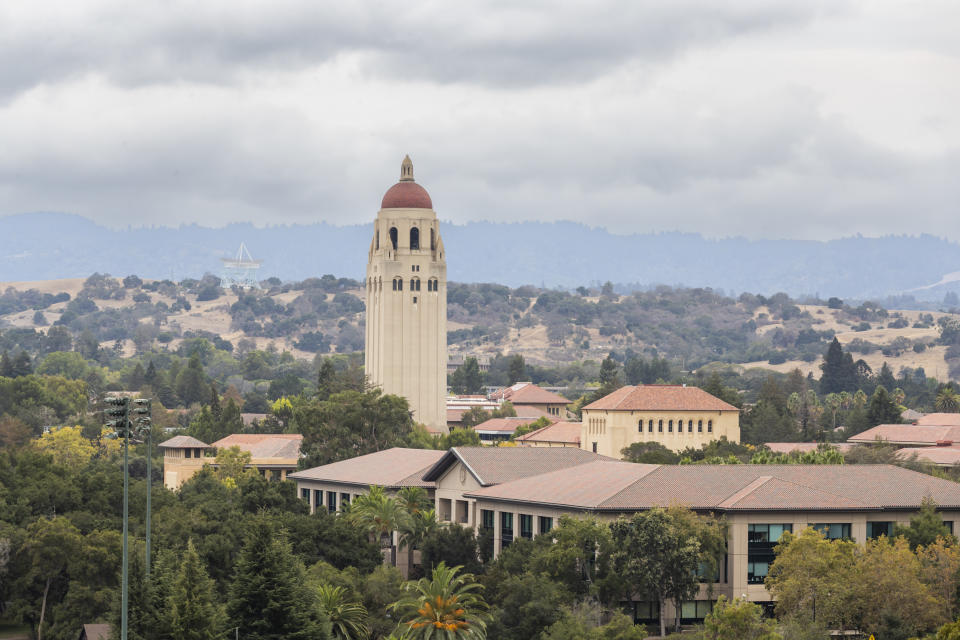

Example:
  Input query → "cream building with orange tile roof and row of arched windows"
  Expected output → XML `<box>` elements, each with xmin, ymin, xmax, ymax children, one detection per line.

<box><xmin>580</xmin><ymin>384</ymin><xmax>740</xmax><ymax>458</ymax></box>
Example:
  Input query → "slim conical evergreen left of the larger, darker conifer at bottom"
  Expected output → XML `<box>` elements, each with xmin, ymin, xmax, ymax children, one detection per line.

<box><xmin>166</xmin><ymin>540</ymin><xmax>227</xmax><ymax>640</ymax></box>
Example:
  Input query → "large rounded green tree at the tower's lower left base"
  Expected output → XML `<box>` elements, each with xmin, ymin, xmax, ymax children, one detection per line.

<box><xmin>294</xmin><ymin>389</ymin><xmax>413</xmax><ymax>469</ymax></box>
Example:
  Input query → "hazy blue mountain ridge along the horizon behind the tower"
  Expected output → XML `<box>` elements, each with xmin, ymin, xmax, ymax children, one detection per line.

<box><xmin>0</xmin><ymin>213</ymin><xmax>960</xmax><ymax>301</ymax></box>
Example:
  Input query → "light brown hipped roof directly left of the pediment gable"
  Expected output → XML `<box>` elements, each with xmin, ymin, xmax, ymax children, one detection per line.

<box><xmin>287</xmin><ymin>447</ymin><xmax>446</xmax><ymax>488</ymax></box>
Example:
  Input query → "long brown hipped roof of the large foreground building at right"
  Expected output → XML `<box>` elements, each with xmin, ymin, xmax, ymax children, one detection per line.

<box><xmin>466</xmin><ymin>462</ymin><xmax>960</xmax><ymax>511</ymax></box>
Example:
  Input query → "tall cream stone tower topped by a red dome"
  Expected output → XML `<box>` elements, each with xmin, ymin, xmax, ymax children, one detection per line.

<box><xmin>364</xmin><ymin>156</ymin><xmax>447</xmax><ymax>432</ymax></box>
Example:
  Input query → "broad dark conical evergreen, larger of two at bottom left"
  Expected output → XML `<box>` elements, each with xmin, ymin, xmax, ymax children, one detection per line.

<box><xmin>227</xmin><ymin>516</ymin><xmax>330</xmax><ymax>640</ymax></box>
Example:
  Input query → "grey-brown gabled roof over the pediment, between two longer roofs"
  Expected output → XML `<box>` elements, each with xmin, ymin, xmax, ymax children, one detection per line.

<box><xmin>423</xmin><ymin>447</ymin><xmax>613</xmax><ymax>486</ymax></box>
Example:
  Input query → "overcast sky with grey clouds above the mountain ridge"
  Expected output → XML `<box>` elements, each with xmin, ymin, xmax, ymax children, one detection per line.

<box><xmin>0</xmin><ymin>0</ymin><xmax>960</xmax><ymax>240</ymax></box>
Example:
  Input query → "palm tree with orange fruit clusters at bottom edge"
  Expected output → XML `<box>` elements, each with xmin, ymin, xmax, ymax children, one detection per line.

<box><xmin>390</xmin><ymin>562</ymin><xmax>489</xmax><ymax>640</ymax></box>
